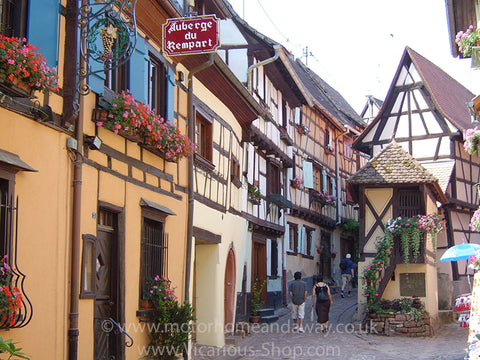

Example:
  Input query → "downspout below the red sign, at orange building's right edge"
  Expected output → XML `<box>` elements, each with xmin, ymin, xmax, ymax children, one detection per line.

<box><xmin>185</xmin><ymin>53</ymin><xmax>214</xmax><ymax>302</ymax></box>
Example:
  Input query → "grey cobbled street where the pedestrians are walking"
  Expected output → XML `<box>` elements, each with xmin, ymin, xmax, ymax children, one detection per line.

<box><xmin>191</xmin><ymin>289</ymin><xmax>468</xmax><ymax>360</ymax></box>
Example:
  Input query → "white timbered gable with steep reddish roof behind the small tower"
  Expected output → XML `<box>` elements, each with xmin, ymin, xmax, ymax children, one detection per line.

<box><xmin>354</xmin><ymin>48</ymin><xmax>470</xmax><ymax>160</ymax></box>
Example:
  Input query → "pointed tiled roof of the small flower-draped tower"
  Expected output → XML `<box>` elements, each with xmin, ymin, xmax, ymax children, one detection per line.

<box><xmin>347</xmin><ymin>142</ymin><xmax>437</xmax><ymax>184</ymax></box>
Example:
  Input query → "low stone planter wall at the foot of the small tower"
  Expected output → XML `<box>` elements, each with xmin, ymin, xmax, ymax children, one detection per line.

<box><xmin>365</xmin><ymin>313</ymin><xmax>433</xmax><ymax>337</ymax></box>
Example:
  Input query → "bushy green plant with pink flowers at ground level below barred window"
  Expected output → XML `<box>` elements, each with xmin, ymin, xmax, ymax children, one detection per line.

<box><xmin>145</xmin><ymin>275</ymin><xmax>194</xmax><ymax>360</ymax></box>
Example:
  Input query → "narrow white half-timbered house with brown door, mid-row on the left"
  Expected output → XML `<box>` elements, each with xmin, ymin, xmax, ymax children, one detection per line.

<box><xmin>219</xmin><ymin>3</ymin><xmax>311</xmax><ymax>319</ymax></box>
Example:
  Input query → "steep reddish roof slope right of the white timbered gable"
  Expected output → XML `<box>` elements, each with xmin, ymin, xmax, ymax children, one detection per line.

<box><xmin>406</xmin><ymin>47</ymin><xmax>475</xmax><ymax>130</ymax></box>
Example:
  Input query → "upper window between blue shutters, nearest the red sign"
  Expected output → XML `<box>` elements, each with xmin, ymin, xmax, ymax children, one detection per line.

<box><xmin>148</xmin><ymin>53</ymin><xmax>167</xmax><ymax>117</ymax></box>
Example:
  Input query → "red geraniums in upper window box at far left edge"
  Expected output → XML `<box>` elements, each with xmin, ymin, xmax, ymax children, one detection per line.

<box><xmin>0</xmin><ymin>35</ymin><xmax>58</xmax><ymax>96</ymax></box>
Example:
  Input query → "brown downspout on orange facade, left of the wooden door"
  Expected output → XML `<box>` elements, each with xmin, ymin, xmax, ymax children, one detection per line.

<box><xmin>65</xmin><ymin>0</ymin><xmax>81</xmax><ymax>360</ymax></box>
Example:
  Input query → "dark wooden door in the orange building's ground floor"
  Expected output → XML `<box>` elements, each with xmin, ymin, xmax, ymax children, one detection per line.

<box><xmin>94</xmin><ymin>214</ymin><xmax>121</xmax><ymax>360</ymax></box>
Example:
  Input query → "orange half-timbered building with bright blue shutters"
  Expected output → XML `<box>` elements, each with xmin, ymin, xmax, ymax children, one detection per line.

<box><xmin>0</xmin><ymin>0</ymin><xmax>198</xmax><ymax>359</ymax></box>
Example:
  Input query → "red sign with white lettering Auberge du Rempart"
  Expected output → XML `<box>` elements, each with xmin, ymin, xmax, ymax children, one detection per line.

<box><xmin>162</xmin><ymin>15</ymin><xmax>219</xmax><ymax>56</ymax></box>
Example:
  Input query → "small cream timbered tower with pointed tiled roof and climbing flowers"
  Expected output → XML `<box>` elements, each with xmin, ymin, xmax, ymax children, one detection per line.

<box><xmin>348</xmin><ymin>140</ymin><xmax>447</xmax><ymax>328</ymax></box>
